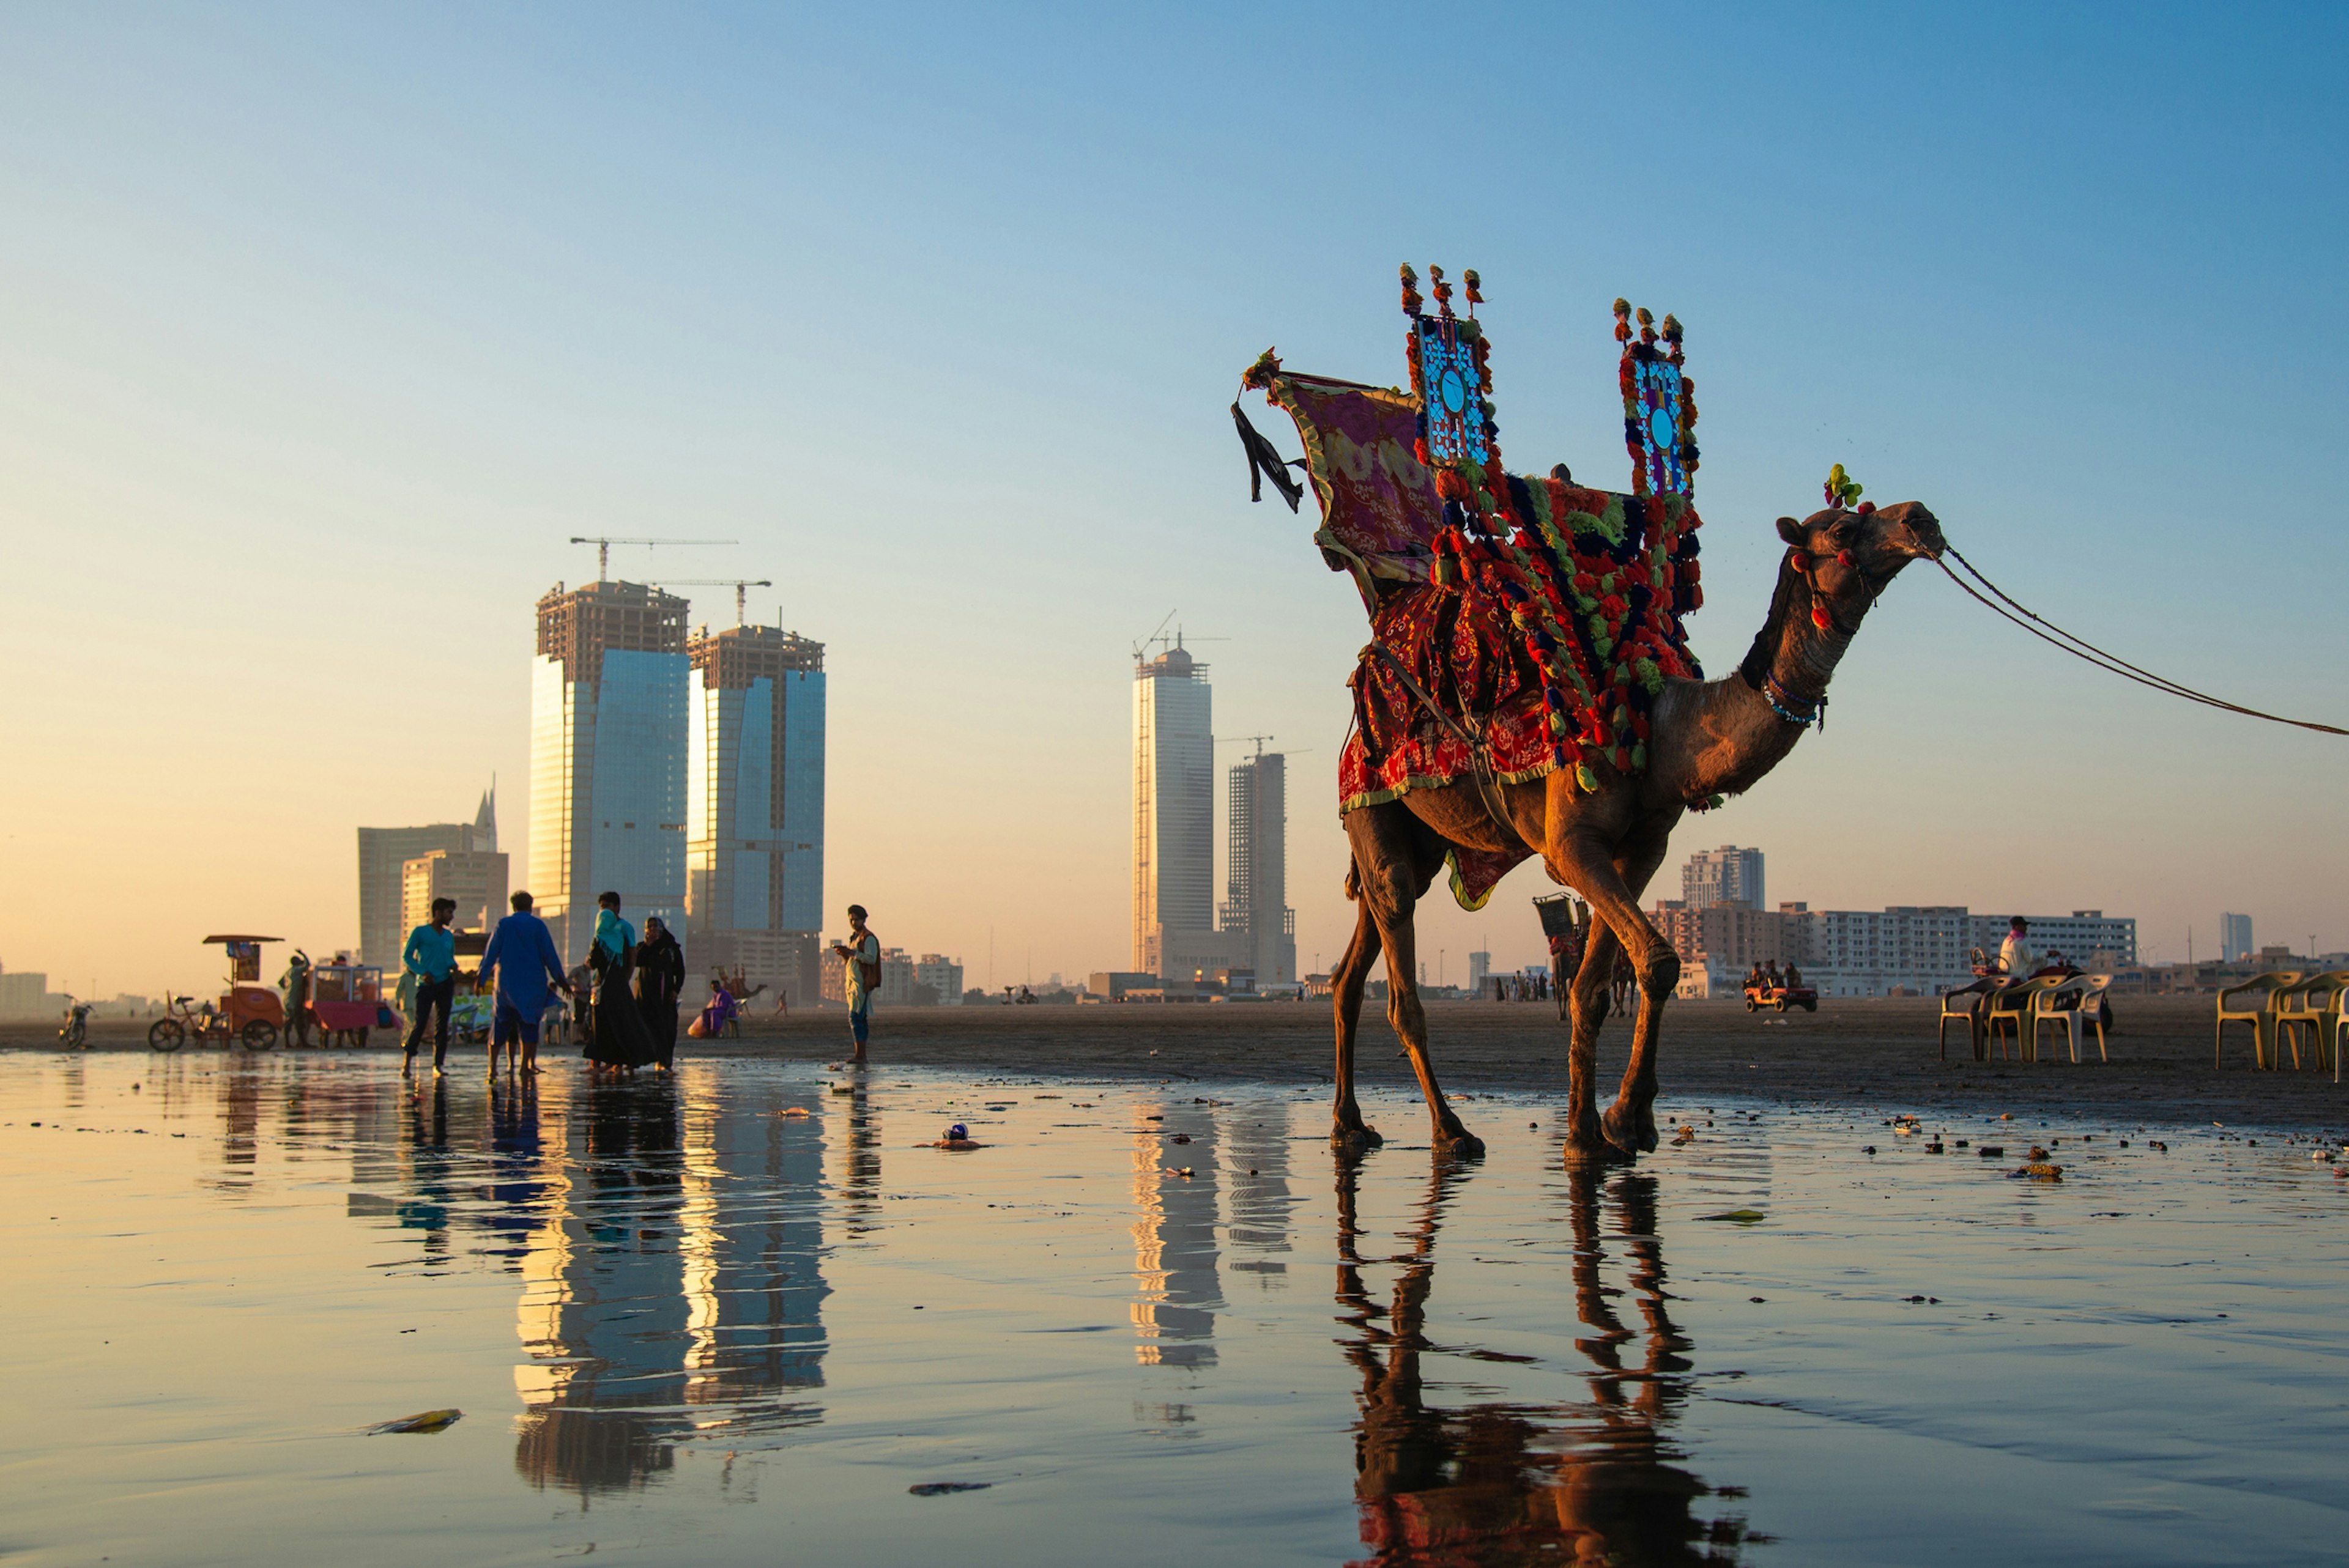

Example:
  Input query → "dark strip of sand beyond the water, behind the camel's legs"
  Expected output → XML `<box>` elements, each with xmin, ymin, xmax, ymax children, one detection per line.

<box><xmin>23</xmin><ymin>997</ymin><xmax>2349</xmax><ymax>1129</ymax></box>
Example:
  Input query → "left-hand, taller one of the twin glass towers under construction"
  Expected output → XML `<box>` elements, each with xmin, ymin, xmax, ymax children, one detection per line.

<box><xmin>529</xmin><ymin>582</ymin><xmax>693</xmax><ymax>965</ymax></box>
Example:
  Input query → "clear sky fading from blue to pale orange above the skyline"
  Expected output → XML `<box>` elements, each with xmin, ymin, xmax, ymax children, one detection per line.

<box><xmin>0</xmin><ymin>2</ymin><xmax>2349</xmax><ymax>995</ymax></box>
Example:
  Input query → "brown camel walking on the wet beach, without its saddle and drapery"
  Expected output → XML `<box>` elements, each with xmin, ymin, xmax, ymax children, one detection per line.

<box><xmin>1329</xmin><ymin>500</ymin><xmax>1943</xmax><ymax>1162</ymax></box>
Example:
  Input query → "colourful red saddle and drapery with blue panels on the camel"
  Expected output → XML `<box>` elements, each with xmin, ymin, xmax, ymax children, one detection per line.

<box><xmin>1231</xmin><ymin>265</ymin><xmax>1705</xmax><ymax>908</ymax></box>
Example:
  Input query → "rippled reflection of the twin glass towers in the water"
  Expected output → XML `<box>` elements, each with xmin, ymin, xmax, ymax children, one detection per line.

<box><xmin>514</xmin><ymin>1068</ymin><xmax>829</xmax><ymax>1500</ymax></box>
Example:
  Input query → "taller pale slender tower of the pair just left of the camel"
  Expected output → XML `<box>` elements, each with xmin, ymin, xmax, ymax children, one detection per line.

<box><xmin>1132</xmin><ymin>638</ymin><xmax>1259</xmax><ymax>991</ymax></box>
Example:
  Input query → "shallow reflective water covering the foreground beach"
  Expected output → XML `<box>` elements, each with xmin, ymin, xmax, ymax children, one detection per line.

<box><xmin>0</xmin><ymin>1054</ymin><xmax>2349</xmax><ymax>1566</ymax></box>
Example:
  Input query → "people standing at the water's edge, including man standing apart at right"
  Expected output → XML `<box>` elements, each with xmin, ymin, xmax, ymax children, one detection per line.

<box><xmin>390</xmin><ymin>892</ymin><xmax>881</xmax><ymax>1078</ymax></box>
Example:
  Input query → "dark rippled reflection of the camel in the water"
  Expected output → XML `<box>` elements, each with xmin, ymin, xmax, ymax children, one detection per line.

<box><xmin>1337</xmin><ymin>1157</ymin><xmax>1762</xmax><ymax>1568</ymax></box>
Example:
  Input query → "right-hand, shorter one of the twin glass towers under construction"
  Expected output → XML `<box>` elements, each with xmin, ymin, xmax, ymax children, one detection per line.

<box><xmin>686</xmin><ymin>627</ymin><xmax>825</xmax><ymax>1005</ymax></box>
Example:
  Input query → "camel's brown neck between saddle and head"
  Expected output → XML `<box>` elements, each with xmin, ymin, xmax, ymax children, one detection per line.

<box><xmin>1649</xmin><ymin>577</ymin><xmax>1851</xmax><ymax>803</ymax></box>
